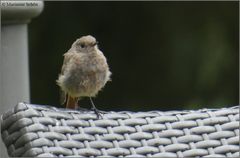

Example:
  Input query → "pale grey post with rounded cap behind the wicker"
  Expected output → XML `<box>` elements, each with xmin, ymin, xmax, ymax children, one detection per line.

<box><xmin>0</xmin><ymin>1</ymin><xmax>43</xmax><ymax>157</ymax></box>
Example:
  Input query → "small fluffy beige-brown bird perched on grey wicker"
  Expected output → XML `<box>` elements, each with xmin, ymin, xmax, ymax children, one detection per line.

<box><xmin>56</xmin><ymin>35</ymin><xmax>112</xmax><ymax>116</ymax></box>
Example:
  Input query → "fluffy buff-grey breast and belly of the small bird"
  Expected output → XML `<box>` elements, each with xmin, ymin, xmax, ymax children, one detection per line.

<box><xmin>62</xmin><ymin>54</ymin><xmax>110</xmax><ymax>96</ymax></box>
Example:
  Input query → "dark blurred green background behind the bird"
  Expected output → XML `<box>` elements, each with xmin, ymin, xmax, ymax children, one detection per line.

<box><xmin>29</xmin><ymin>1</ymin><xmax>239</xmax><ymax>111</ymax></box>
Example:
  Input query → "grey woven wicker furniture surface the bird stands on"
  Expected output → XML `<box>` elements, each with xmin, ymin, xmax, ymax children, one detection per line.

<box><xmin>1</xmin><ymin>103</ymin><xmax>239</xmax><ymax>157</ymax></box>
